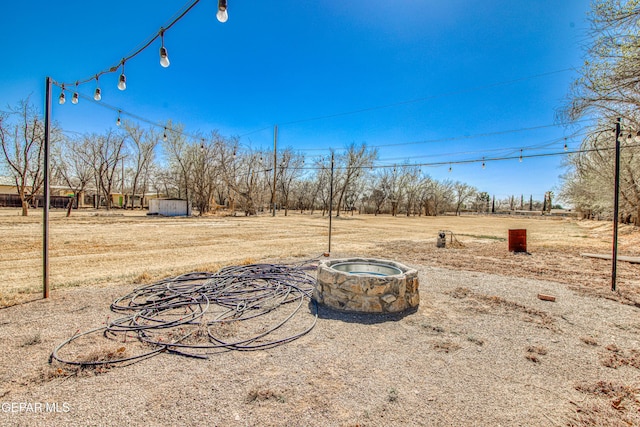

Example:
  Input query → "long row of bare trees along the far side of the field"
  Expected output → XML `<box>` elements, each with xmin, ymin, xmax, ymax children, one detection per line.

<box><xmin>0</xmin><ymin>99</ymin><xmax>556</xmax><ymax>216</ymax></box>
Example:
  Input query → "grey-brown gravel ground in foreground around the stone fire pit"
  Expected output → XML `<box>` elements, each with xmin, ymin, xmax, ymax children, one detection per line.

<box><xmin>0</xmin><ymin>262</ymin><xmax>640</xmax><ymax>426</ymax></box>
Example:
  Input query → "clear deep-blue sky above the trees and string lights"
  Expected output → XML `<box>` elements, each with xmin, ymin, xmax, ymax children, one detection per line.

<box><xmin>0</xmin><ymin>0</ymin><xmax>589</xmax><ymax>200</ymax></box>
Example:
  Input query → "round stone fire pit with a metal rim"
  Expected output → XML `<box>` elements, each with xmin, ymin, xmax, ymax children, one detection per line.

<box><xmin>313</xmin><ymin>258</ymin><xmax>420</xmax><ymax>313</ymax></box>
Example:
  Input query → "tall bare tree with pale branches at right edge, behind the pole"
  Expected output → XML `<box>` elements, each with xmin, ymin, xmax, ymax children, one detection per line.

<box><xmin>560</xmin><ymin>0</ymin><xmax>640</xmax><ymax>225</ymax></box>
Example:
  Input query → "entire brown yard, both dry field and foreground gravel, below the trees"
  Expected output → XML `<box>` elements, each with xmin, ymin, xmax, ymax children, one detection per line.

<box><xmin>0</xmin><ymin>209</ymin><xmax>640</xmax><ymax>426</ymax></box>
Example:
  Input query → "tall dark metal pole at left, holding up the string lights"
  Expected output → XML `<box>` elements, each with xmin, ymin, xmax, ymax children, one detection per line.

<box><xmin>42</xmin><ymin>77</ymin><xmax>51</xmax><ymax>298</ymax></box>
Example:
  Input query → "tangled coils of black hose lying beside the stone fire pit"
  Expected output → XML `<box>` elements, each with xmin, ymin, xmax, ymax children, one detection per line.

<box><xmin>50</xmin><ymin>260</ymin><xmax>318</xmax><ymax>367</ymax></box>
